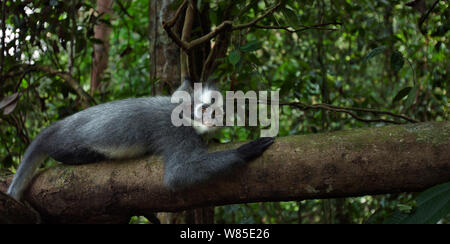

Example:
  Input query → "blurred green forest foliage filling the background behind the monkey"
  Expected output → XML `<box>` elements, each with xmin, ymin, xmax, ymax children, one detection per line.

<box><xmin>0</xmin><ymin>0</ymin><xmax>450</xmax><ymax>223</ymax></box>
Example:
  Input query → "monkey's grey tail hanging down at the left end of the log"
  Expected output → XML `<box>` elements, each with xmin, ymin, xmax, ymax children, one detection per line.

<box><xmin>8</xmin><ymin>138</ymin><xmax>47</xmax><ymax>201</ymax></box>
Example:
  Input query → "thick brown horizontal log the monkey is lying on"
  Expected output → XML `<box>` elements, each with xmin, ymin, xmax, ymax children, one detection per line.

<box><xmin>0</xmin><ymin>122</ymin><xmax>450</xmax><ymax>223</ymax></box>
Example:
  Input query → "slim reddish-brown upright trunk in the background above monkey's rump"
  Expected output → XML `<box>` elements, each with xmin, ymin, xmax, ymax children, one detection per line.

<box><xmin>91</xmin><ymin>0</ymin><xmax>114</xmax><ymax>95</ymax></box>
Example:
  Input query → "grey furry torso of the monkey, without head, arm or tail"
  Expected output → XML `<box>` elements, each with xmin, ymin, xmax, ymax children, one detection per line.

<box><xmin>38</xmin><ymin>97</ymin><xmax>186</xmax><ymax>164</ymax></box>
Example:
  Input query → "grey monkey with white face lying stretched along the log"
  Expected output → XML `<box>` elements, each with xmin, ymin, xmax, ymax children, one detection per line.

<box><xmin>7</xmin><ymin>79</ymin><xmax>275</xmax><ymax>201</ymax></box>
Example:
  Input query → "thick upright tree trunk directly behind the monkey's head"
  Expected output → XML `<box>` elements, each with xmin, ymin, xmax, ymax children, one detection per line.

<box><xmin>149</xmin><ymin>0</ymin><xmax>214</xmax><ymax>224</ymax></box>
